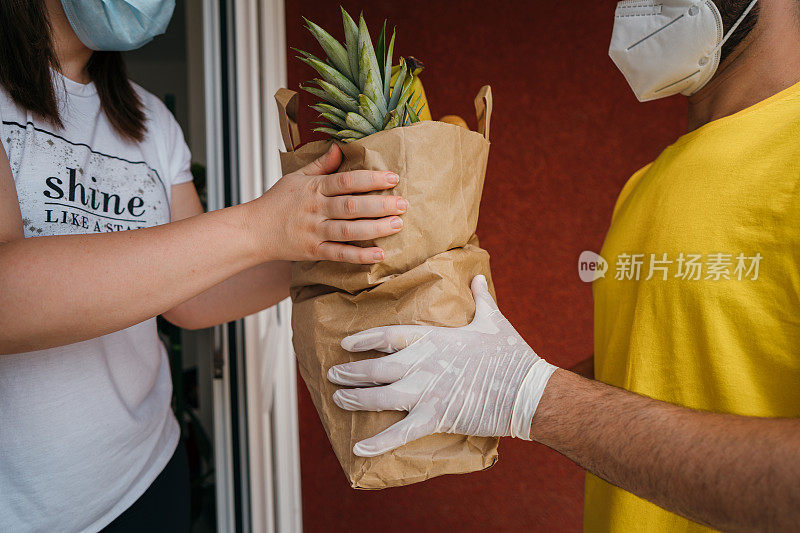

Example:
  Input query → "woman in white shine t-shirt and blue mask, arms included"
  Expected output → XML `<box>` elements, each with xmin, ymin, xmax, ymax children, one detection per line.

<box><xmin>0</xmin><ymin>0</ymin><xmax>407</xmax><ymax>532</ymax></box>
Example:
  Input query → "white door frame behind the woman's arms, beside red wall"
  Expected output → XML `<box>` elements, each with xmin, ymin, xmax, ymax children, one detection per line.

<box><xmin>203</xmin><ymin>0</ymin><xmax>302</xmax><ymax>533</ymax></box>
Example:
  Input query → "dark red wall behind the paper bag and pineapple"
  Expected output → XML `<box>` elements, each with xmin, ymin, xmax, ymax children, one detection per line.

<box><xmin>286</xmin><ymin>0</ymin><xmax>686</xmax><ymax>532</ymax></box>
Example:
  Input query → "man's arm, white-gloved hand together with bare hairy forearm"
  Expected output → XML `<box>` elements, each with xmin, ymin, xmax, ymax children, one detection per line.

<box><xmin>328</xmin><ymin>276</ymin><xmax>800</xmax><ymax>531</ymax></box>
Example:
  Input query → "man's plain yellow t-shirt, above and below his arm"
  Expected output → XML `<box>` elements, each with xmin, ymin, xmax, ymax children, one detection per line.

<box><xmin>584</xmin><ymin>83</ymin><xmax>800</xmax><ymax>532</ymax></box>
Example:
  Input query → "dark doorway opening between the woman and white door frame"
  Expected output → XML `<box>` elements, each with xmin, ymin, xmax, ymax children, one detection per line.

<box><xmin>125</xmin><ymin>0</ymin><xmax>212</xmax><ymax>533</ymax></box>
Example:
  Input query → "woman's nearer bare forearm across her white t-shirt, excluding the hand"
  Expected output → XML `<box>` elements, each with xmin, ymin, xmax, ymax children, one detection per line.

<box><xmin>0</xmin><ymin>205</ymin><xmax>258</xmax><ymax>354</ymax></box>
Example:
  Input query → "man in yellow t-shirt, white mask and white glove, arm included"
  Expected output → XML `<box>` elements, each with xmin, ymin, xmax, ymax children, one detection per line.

<box><xmin>329</xmin><ymin>0</ymin><xmax>800</xmax><ymax>531</ymax></box>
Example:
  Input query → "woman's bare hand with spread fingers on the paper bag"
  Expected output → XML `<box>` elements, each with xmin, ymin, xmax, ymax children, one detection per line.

<box><xmin>246</xmin><ymin>144</ymin><xmax>408</xmax><ymax>264</ymax></box>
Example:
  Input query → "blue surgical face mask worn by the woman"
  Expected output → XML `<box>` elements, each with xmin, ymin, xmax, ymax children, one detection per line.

<box><xmin>61</xmin><ymin>0</ymin><xmax>175</xmax><ymax>52</ymax></box>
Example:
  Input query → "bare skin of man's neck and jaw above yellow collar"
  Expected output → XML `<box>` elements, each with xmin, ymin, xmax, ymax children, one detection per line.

<box><xmin>687</xmin><ymin>2</ymin><xmax>800</xmax><ymax>131</ymax></box>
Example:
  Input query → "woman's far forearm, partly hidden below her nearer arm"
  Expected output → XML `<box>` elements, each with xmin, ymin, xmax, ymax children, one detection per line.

<box><xmin>163</xmin><ymin>261</ymin><xmax>291</xmax><ymax>329</ymax></box>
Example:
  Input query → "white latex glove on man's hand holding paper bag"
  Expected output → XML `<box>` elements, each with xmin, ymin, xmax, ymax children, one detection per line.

<box><xmin>328</xmin><ymin>276</ymin><xmax>556</xmax><ymax>457</ymax></box>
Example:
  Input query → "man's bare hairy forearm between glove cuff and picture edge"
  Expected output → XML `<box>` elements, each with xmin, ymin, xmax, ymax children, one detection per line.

<box><xmin>532</xmin><ymin>370</ymin><xmax>800</xmax><ymax>530</ymax></box>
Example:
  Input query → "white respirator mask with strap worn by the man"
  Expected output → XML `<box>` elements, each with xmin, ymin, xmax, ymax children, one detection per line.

<box><xmin>608</xmin><ymin>0</ymin><xmax>758</xmax><ymax>102</ymax></box>
